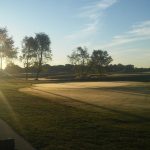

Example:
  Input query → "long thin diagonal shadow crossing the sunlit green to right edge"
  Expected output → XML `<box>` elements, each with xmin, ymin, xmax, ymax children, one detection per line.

<box><xmin>31</xmin><ymin>88</ymin><xmax>150</xmax><ymax>122</ymax></box>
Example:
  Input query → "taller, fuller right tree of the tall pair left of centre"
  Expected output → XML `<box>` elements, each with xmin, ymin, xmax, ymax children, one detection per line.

<box><xmin>35</xmin><ymin>33</ymin><xmax>52</xmax><ymax>80</ymax></box>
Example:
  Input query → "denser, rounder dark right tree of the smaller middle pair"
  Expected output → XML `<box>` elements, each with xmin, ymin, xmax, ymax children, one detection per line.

<box><xmin>91</xmin><ymin>50</ymin><xmax>113</xmax><ymax>73</ymax></box>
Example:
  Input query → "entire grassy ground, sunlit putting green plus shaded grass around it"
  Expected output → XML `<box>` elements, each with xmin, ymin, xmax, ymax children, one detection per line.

<box><xmin>0</xmin><ymin>80</ymin><xmax>150</xmax><ymax>150</ymax></box>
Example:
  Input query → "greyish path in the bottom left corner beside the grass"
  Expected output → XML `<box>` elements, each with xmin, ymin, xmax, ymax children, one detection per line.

<box><xmin>0</xmin><ymin>119</ymin><xmax>35</xmax><ymax>150</ymax></box>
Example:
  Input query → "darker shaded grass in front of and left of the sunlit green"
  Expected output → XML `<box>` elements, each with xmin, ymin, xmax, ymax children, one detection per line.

<box><xmin>0</xmin><ymin>80</ymin><xmax>150</xmax><ymax>150</ymax></box>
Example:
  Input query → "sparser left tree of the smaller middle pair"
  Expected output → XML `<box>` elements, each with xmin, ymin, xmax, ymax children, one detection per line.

<box><xmin>68</xmin><ymin>47</ymin><xmax>89</xmax><ymax>75</ymax></box>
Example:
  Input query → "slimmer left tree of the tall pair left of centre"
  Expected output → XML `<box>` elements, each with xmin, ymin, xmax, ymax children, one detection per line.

<box><xmin>20</xmin><ymin>36</ymin><xmax>37</xmax><ymax>80</ymax></box>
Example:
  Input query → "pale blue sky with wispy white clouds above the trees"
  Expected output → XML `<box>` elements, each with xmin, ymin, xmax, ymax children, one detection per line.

<box><xmin>0</xmin><ymin>0</ymin><xmax>150</xmax><ymax>67</ymax></box>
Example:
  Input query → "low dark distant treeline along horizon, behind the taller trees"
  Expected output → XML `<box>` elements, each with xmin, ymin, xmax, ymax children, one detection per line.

<box><xmin>5</xmin><ymin>63</ymin><xmax>150</xmax><ymax>77</ymax></box>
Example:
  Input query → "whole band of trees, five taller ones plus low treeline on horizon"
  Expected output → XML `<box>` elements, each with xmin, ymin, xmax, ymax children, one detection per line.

<box><xmin>0</xmin><ymin>28</ymin><xmax>149</xmax><ymax>80</ymax></box>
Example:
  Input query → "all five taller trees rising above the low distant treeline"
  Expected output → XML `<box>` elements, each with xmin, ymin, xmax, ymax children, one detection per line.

<box><xmin>0</xmin><ymin>28</ymin><xmax>112</xmax><ymax>80</ymax></box>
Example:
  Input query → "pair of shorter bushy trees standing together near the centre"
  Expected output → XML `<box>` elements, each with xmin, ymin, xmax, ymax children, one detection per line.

<box><xmin>68</xmin><ymin>47</ymin><xmax>113</xmax><ymax>76</ymax></box>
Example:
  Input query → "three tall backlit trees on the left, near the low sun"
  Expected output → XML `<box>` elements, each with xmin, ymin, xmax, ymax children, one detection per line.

<box><xmin>0</xmin><ymin>28</ymin><xmax>52</xmax><ymax>80</ymax></box>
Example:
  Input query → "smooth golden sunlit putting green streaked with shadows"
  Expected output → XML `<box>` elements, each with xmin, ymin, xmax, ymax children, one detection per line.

<box><xmin>21</xmin><ymin>82</ymin><xmax>150</xmax><ymax>111</ymax></box>
